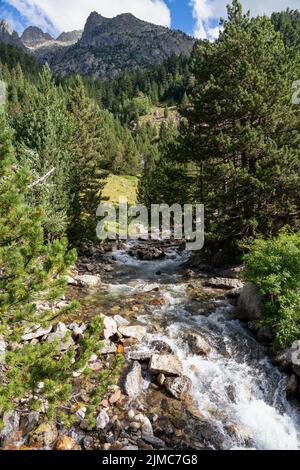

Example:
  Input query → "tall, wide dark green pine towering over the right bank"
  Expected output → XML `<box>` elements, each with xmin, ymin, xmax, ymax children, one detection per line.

<box><xmin>182</xmin><ymin>0</ymin><xmax>300</xmax><ymax>250</ymax></box>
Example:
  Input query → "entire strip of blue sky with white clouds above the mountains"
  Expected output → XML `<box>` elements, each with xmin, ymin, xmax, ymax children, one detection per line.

<box><xmin>0</xmin><ymin>0</ymin><xmax>300</xmax><ymax>39</ymax></box>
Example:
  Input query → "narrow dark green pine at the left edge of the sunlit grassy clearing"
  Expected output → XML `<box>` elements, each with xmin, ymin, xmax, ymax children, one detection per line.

<box><xmin>68</xmin><ymin>76</ymin><xmax>107</xmax><ymax>239</ymax></box>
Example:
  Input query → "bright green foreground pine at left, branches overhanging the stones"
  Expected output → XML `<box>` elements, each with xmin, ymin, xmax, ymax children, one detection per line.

<box><xmin>0</xmin><ymin>110</ymin><xmax>122</xmax><ymax>420</ymax></box>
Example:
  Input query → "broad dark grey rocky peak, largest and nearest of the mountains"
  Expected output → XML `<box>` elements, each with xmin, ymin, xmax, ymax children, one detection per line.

<box><xmin>48</xmin><ymin>12</ymin><xmax>194</xmax><ymax>78</ymax></box>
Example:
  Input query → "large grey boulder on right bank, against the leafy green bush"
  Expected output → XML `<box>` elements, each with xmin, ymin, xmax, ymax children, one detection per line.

<box><xmin>237</xmin><ymin>282</ymin><xmax>263</xmax><ymax>321</ymax></box>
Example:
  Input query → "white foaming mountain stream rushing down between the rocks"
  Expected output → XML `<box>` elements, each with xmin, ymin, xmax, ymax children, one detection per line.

<box><xmin>97</xmin><ymin>244</ymin><xmax>300</xmax><ymax>450</ymax></box>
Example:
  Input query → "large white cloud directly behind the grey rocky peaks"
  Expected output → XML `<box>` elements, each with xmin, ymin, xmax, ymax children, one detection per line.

<box><xmin>7</xmin><ymin>0</ymin><xmax>171</xmax><ymax>32</ymax></box>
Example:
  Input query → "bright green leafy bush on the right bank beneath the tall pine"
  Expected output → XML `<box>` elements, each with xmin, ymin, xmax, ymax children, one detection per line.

<box><xmin>244</xmin><ymin>230</ymin><xmax>300</xmax><ymax>347</ymax></box>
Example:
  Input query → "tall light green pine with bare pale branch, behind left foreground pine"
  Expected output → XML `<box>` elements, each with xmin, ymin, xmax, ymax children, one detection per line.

<box><xmin>13</xmin><ymin>66</ymin><xmax>71</xmax><ymax>238</ymax></box>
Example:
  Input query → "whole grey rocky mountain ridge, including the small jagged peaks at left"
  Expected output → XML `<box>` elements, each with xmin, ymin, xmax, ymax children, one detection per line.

<box><xmin>0</xmin><ymin>12</ymin><xmax>194</xmax><ymax>78</ymax></box>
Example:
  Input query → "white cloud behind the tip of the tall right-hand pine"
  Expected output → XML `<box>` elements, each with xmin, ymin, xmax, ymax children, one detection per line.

<box><xmin>190</xmin><ymin>0</ymin><xmax>299</xmax><ymax>39</ymax></box>
